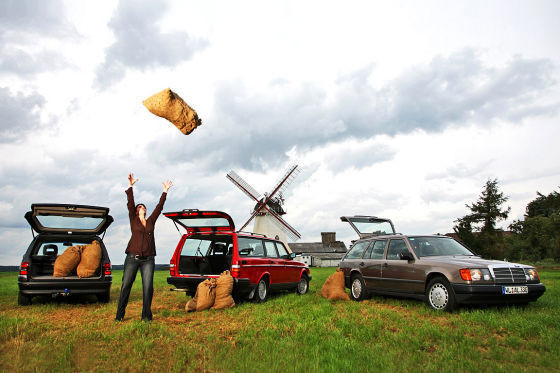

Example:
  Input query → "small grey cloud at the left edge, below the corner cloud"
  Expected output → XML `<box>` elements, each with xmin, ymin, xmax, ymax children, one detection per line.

<box><xmin>0</xmin><ymin>87</ymin><xmax>45</xmax><ymax>143</ymax></box>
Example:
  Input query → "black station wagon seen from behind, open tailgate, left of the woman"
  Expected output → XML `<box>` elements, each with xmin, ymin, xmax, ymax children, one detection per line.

<box><xmin>18</xmin><ymin>203</ymin><xmax>113</xmax><ymax>305</ymax></box>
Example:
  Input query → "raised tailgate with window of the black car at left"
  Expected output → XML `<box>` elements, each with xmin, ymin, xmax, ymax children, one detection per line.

<box><xmin>25</xmin><ymin>203</ymin><xmax>113</xmax><ymax>235</ymax></box>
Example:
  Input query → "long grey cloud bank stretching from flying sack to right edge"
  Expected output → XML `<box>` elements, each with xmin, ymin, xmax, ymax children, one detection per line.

<box><xmin>149</xmin><ymin>49</ymin><xmax>558</xmax><ymax>170</ymax></box>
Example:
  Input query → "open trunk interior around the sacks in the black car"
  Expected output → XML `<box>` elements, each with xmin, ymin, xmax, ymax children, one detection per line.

<box><xmin>29</xmin><ymin>239</ymin><xmax>104</xmax><ymax>280</ymax></box>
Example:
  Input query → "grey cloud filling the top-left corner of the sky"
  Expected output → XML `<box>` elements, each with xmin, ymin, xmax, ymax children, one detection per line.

<box><xmin>0</xmin><ymin>0</ymin><xmax>78</xmax><ymax>76</ymax></box>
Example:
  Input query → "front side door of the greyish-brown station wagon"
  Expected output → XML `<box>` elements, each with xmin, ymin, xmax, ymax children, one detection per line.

<box><xmin>381</xmin><ymin>238</ymin><xmax>424</xmax><ymax>294</ymax></box>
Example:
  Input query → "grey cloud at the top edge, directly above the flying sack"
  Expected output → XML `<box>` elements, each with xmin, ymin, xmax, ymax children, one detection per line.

<box><xmin>95</xmin><ymin>0</ymin><xmax>207</xmax><ymax>89</ymax></box>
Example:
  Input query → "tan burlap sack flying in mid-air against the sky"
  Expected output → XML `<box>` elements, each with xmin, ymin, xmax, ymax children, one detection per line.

<box><xmin>142</xmin><ymin>88</ymin><xmax>202</xmax><ymax>135</ymax></box>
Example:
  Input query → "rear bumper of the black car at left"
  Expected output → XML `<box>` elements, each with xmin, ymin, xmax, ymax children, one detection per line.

<box><xmin>18</xmin><ymin>279</ymin><xmax>112</xmax><ymax>296</ymax></box>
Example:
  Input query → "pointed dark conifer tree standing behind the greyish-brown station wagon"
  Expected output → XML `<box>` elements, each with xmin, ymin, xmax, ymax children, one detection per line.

<box><xmin>453</xmin><ymin>179</ymin><xmax>511</xmax><ymax>258</ymax></box>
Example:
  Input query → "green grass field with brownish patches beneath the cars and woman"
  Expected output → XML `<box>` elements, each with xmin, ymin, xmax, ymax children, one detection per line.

<box><xmin>0</xmin><ymin>268</ymin><xmax>560</xmax><ymax>372</ymax></box>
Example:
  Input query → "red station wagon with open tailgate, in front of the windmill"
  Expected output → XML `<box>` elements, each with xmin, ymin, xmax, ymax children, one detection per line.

<box><xmin>163</xmin><ymin>210</ymin><xmax>311</xmax><ymax>302</ymax></box>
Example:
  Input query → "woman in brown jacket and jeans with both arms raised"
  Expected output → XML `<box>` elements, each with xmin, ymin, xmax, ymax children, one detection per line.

<box><xmin>115</xmin><ymin>173</ymin><xmax>173</xmax><ymax>321</ymax></box>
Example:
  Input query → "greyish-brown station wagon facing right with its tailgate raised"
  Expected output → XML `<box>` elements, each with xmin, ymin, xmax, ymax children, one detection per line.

<box><xmin>339</xmin><ymin>216</ymin><xmax>545</xmax><ymax>311</ymax></box>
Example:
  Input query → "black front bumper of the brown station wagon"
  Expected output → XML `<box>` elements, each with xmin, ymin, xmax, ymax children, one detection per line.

<box><xmin>453</xmin><ymin>284</ymin><xmax>546</xmax><ymax>304</ymax></box>
